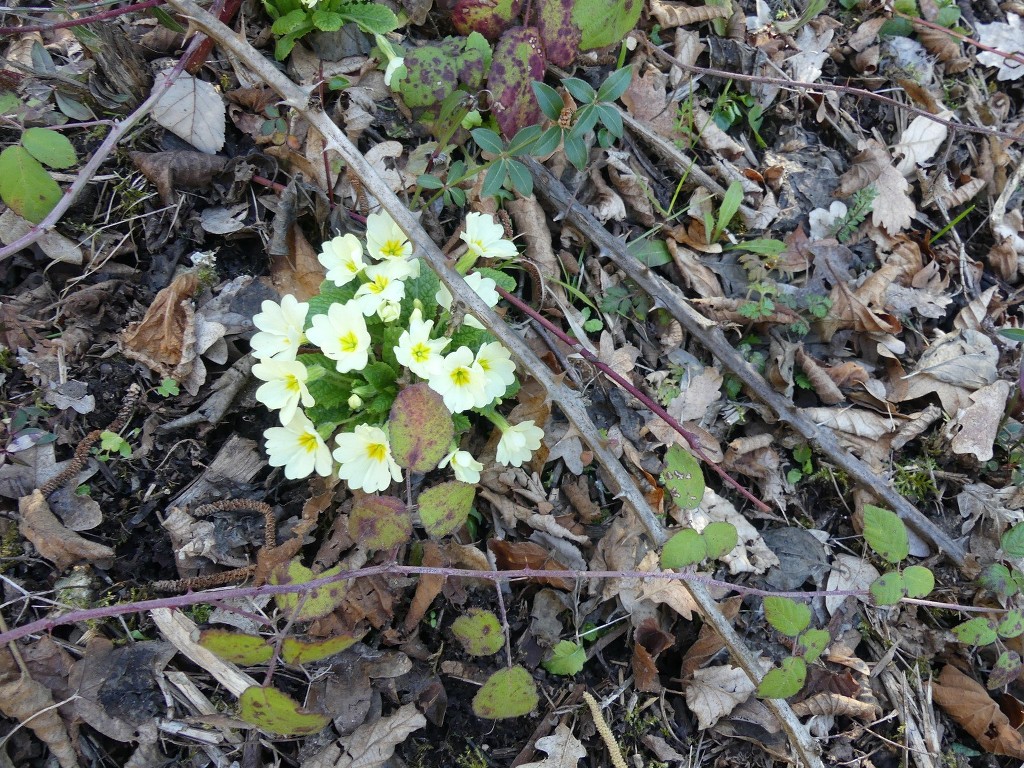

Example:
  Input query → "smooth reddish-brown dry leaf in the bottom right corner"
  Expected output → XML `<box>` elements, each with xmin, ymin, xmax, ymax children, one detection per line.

<box><xmin>932</xmin><ymin>664</ymin><xmax>1024</xmax><ymax>760</ymax></box>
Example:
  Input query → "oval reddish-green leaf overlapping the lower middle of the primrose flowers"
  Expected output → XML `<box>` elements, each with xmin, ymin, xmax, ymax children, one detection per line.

<box><xmin>388</xmin><ymin>382</ymin><xmax>455</xmax><ymax>472</ymax></box>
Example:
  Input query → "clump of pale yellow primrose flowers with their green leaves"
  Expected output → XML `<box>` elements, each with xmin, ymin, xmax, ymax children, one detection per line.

<box><xmin>251</xmin><ymin>213</ymin><xmax>544</xmax><ymax>493</ymax></box>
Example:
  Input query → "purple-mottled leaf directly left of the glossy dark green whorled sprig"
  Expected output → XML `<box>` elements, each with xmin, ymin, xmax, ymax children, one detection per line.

<box><xmin>487</xmin><ymin>27</ymin><xmax>546</xmax><ymax>137</ymax></box>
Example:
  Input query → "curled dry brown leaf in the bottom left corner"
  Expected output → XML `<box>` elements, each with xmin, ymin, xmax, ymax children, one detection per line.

<box><xmin>0</xmin><ymin>648</ymin><xmax>79</xmax><ymax>768</ymax></box>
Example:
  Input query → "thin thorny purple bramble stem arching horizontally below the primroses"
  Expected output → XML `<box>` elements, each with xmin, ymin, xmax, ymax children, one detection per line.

<box><xmin>0</xmin><ymin>563</ymin><xmax>1005</xmax><ymax>645</ymax></box>
